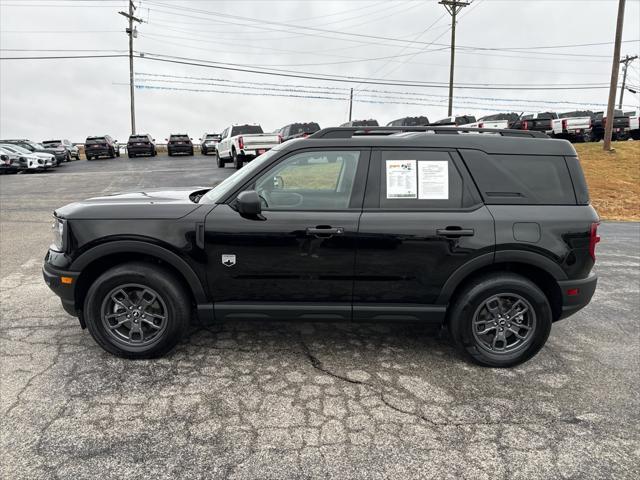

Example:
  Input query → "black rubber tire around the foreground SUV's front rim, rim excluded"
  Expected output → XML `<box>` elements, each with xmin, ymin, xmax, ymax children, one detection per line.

<box><xmin>84</xmin><ymin>262</ymin><xmax>191</xmax><ymax>358</ymax></box>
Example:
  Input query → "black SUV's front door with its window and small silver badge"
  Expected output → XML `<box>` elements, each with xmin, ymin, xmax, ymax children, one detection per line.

<box><xmin>205</xmin><ymin>149</ymin><xmax>369</xmax><ymax>320</ymax></box>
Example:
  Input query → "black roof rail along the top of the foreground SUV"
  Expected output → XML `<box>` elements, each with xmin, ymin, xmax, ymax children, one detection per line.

<box><xmin>307</xmin><ymin>126</ymin><xmax>549</xmax><ymax>138</ymax></box>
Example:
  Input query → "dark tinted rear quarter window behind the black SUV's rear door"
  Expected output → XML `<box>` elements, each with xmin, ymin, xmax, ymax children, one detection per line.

<box><xmin>461</xmin><ymin>150</ymin><xmax>576</xmax><ymax>205</ymax></box>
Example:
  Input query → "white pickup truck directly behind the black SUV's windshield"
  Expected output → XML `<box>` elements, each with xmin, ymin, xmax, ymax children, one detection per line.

<box><xmin>216</xmin><ymin>125</ymin><xmax>280</xmax><ymax>169</ymax></box>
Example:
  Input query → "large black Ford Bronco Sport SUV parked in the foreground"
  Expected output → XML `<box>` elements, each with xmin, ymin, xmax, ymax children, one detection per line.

<box><xmin>44</xmin><ymin>127</ymin><xmax>599</xmax><ymax>367</ymax></box>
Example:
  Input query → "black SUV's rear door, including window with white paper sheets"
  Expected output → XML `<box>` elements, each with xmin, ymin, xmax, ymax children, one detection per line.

<box><xmin>353</xmin><ymin>149</ymin><xmax>495</xmax><ymax>321</ymax></box>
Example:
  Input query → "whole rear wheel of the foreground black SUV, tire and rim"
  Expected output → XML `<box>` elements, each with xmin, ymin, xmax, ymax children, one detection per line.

<box><xmin>448</xmin><ymin>273</ymin><xmax>552</xmax><ymax>367</ymax></box>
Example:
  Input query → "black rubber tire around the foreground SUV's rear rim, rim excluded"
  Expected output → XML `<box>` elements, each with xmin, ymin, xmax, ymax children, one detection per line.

<box><xmin>447</xmin><ymin>273</ymin><xmax>553</xmax><ymax>368</ymax></box>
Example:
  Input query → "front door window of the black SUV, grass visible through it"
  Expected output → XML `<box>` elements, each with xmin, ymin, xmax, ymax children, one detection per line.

<box><xmin>255</xmin><ymin>150</ymin><xmax>360</xmax><ymax>210</ymax></box>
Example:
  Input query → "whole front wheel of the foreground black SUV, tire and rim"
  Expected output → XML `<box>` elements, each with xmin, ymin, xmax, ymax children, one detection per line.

<box><xmin>84</xmin><ymin>262</ymin><xmax>190</xmax><ymax>358</ymax></box>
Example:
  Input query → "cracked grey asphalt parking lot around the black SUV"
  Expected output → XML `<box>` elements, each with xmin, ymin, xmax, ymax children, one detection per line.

<box><xmin>0</xmin><ymin>156</ymin><xmax>640</xmax><ymax>480</ymax></box>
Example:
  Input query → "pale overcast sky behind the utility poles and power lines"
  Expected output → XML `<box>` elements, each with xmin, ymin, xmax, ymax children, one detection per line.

<box><xmin>0</xmin><ymin>0</ymin><xmax>640</xmax><ymax>142</ymax></box>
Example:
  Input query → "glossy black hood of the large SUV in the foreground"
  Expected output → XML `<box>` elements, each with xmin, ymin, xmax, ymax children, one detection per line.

<box><xmin>55</xmin><ymin>187</ymin><xmax>210</xmax><ymax>220</ymax></box>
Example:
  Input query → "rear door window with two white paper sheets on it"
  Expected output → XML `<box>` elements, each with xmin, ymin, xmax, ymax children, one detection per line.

<box><xmin>380</xmin><ymin>150</ymin><xmax>465</xmax><ymax>209</ymax></box>
